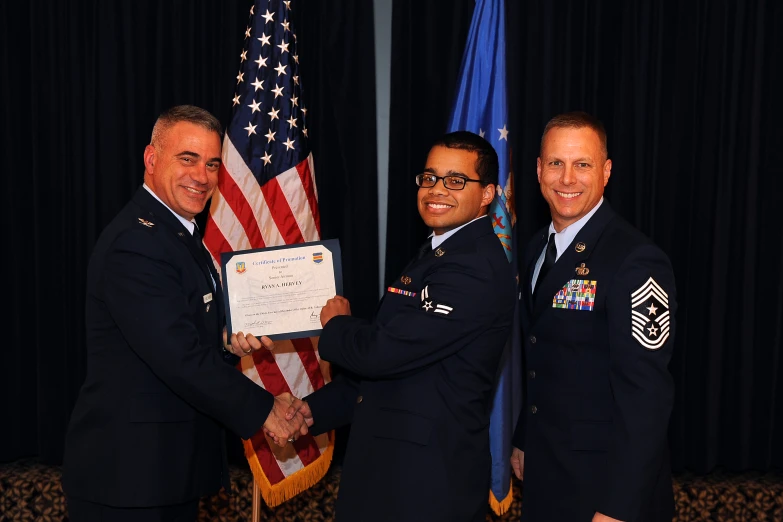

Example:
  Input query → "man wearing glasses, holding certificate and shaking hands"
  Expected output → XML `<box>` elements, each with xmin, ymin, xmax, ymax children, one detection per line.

<box><xmin>278</xmin><ymin>132</ymin><xmax>516</xmax><ymax>522</ymax></box>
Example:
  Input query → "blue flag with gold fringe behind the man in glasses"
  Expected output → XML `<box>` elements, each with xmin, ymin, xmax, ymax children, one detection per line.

<box><xmin>448</xmin><ymin>0</ymin><xmax>522</xmax><ymax>515</ymax></box>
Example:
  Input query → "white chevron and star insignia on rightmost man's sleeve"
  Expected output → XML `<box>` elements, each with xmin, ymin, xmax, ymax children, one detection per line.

<box><xmin>631</xmin><ymin>277</ymin><xmax>669</xmax><ymax>350</ymax></box>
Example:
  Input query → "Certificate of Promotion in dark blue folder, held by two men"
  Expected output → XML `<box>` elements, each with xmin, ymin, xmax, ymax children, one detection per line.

<box><xmin>220</xmin><ymin>239</ymin><xmax>343</xmax><ymax>340</ymax></box>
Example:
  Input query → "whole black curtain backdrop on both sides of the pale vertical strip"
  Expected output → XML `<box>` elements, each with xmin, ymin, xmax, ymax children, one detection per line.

<box><xmin>0</xmin><ymin>0</ymin><xmax>783</xmax><ymax>480</ymax></box>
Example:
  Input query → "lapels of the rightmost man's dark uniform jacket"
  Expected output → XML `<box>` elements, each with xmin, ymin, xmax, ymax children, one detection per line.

<box><xmin>533</xmin><ymin>200</ymin><xmax>615</xmax><ymax>318</ymax></box>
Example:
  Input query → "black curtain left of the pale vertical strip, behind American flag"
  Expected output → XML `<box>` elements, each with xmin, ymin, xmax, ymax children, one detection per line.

<box><xmin>0</xmin><ymin>0</ymin><xmax>378</xmax><ymax>463</ymax></box>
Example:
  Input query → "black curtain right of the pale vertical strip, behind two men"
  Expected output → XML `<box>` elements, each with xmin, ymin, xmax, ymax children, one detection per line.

<box><xmin>385</xmin><ymin>0</ymin><xmax>783</xmax><ymax>473</ymax></box>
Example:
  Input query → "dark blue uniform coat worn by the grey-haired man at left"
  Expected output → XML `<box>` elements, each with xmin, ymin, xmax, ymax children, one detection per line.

<box><xmin>63</xmin><ymin>188</ymin><xmax>273</xmax><ymax>507</ymax></box>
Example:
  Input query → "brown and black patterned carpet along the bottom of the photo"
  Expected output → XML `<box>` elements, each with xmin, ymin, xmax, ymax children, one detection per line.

<box><xmin>0</xmin><ymin>460</ymin><xmax>783</xmax><ymax>522</ymax></box>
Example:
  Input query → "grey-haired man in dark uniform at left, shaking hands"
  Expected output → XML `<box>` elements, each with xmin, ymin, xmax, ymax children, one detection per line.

<box><xmin>63</xmin><ymin>106</ymin><xmax>303</xmax><ymax>522</ymax></box>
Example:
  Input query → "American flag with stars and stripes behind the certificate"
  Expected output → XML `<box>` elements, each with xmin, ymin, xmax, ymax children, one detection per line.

<box><xmin>204</xmin><ymin>0</ymin><xmax>334</xmax><ymax>506</ymax></box>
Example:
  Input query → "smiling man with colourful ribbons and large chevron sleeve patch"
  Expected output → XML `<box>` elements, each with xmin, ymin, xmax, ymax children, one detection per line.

<box><xmin>511</xmin><ymin>113</ymin><xmax>676</xmax><ymax>522</ymax></box>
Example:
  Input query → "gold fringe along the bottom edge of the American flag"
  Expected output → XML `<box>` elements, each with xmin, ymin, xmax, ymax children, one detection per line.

<box><xmin>242</xmin><ymin>431</ymin><xmax>334</xmax><ymax>507</ymax></box>
